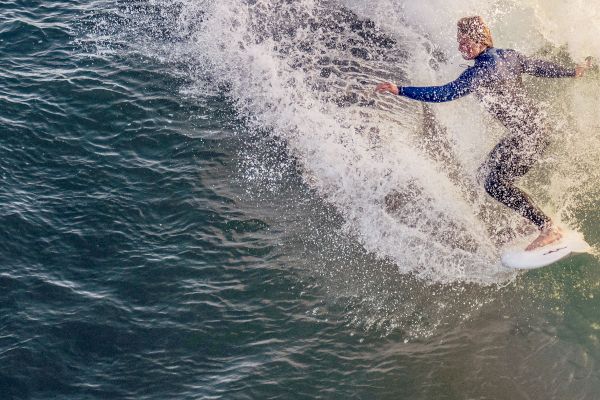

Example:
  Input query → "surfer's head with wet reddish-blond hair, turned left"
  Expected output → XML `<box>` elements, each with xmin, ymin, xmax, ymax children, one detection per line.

<box><xmin>456</xmin><ymin>16</ymin><xmax>494</xmax><ymax>60</ymax></box>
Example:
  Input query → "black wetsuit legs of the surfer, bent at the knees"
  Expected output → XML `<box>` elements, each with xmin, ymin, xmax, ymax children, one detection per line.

<box><xmin>484</xmin><ymin>137</ymin><xmax>550</xmax><ymax>229</ymax></box>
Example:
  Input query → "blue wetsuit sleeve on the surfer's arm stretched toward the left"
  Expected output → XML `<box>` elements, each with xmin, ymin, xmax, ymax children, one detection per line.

<box><xmin>398</xmin><ymin>67</ymin><xmax>480</xmax><ymax>103</ymax></box>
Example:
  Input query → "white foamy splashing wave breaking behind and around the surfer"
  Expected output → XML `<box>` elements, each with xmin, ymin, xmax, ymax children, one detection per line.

<box><xmin>113</xmin><ymin>0</ymin><xmax>600</xmax><ymax>283</ymax></box>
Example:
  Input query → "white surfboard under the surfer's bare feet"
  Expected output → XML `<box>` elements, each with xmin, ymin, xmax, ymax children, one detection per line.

<box><xmin>502</xmin><ymin>230</ymin><xmax>591</xmax><ymax>269</ymax></box>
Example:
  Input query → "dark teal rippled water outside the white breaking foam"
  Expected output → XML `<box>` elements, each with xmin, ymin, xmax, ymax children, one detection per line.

<box><xmin>0</xmin><ymin>0</ymin><xmax>600</xmax><ymax>399</ymax></box>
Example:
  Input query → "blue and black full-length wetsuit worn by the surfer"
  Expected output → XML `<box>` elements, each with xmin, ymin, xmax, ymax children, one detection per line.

<box><xmin>399</xmin><ymin>48</ymin><xmax>575</xmax><ymax>229</ymax></box>
